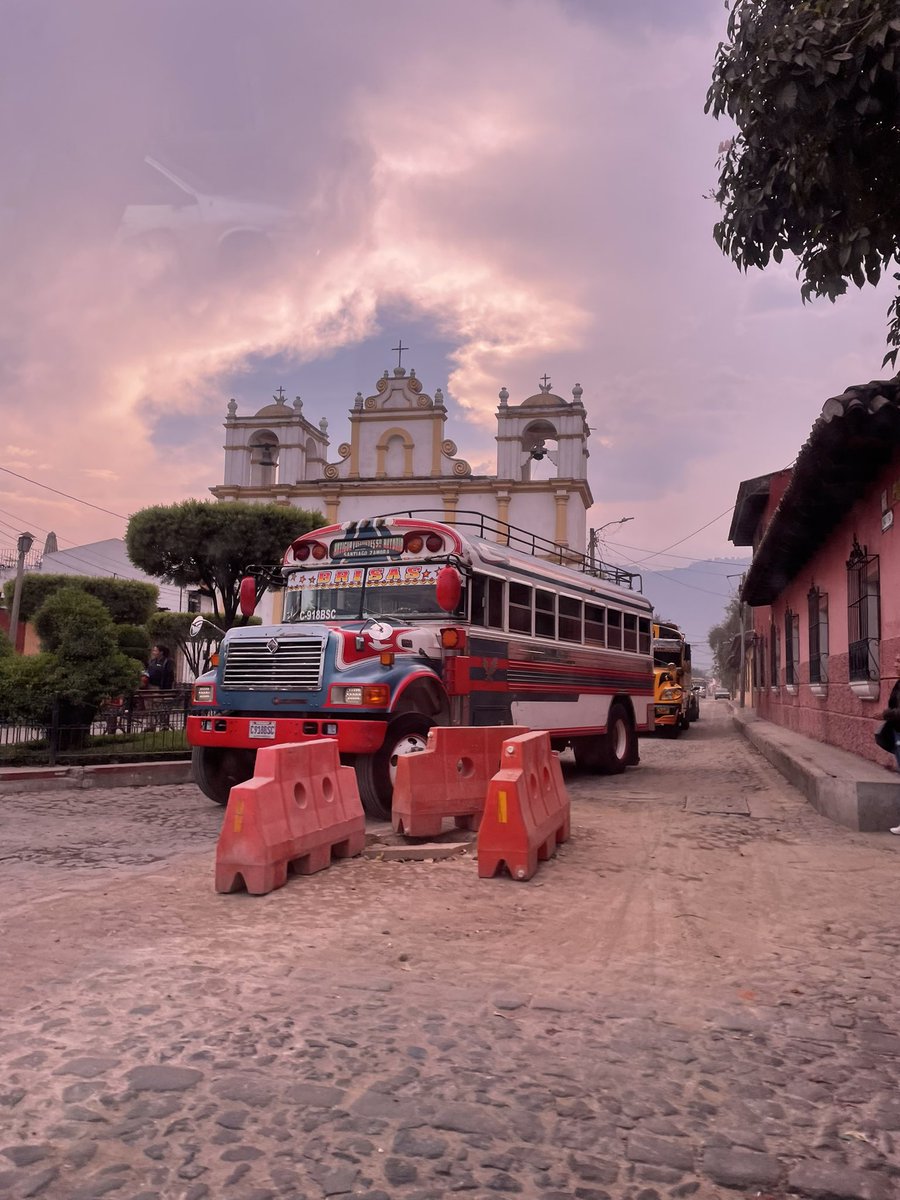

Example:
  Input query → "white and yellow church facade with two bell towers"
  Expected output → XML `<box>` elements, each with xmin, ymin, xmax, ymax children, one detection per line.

<box><xmin>210</xmin><ymin>350</ymin><xmax>593</xmax><ymax>553</ymax></box>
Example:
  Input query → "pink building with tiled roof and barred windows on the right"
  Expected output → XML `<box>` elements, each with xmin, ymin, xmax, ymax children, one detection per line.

<box><xmin>728</xmin><ymin>377</ymin><xmax>900</xmax><ymax>764</ymax></box>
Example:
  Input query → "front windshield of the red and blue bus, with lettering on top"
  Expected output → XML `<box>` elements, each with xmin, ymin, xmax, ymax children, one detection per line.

<box><xmin>283</xmin><ymin>564</ymin><xmax>446</xmax><ymax>623</ymax></box>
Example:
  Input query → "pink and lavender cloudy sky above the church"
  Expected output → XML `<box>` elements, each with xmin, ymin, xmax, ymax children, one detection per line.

<box><xmin>0</xmin><ymin>0</ymin><xmax>889</xmax><ymax>580</ymax></box>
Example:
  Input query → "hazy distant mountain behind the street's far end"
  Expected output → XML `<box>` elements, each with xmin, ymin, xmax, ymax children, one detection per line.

<box><xmin>624</xmin><ymin>547</ymin><xmax>750</xmax><ymax>671</ymax></box>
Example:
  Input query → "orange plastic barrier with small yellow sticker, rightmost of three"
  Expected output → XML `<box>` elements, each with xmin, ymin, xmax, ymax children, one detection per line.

<box><xmin>478</xmin><ymin>733</ymin><xmax>570</xmax><ymax>880</ymax></box>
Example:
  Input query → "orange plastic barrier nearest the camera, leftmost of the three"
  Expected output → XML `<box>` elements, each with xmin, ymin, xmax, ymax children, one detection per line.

<box><xmin>216</xmin><ymin>738</ymin><xmax>366</xmax><ymax>895</ymax></box>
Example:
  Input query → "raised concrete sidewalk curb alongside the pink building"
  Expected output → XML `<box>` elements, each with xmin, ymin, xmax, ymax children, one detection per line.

<box><xmin>732</xmin><ymin>708</ymin><xmax>900</xmax><ymax>833</ymax></box>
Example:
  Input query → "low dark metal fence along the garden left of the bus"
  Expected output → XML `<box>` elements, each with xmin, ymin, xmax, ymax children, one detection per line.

<box><xmin>0</xmin><ymin>688</ymin><xmax>191</xmax><ymax>767</ymax></box>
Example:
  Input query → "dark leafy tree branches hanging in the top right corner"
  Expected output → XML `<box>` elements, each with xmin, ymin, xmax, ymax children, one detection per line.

<box><xmin>706</xmin><ymin>0</ymin><xmax>900</xmax><ymax>365</ymax></box>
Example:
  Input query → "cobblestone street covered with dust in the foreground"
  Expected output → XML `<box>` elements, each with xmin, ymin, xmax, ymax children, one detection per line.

<box><xmin>0</xmin><ymin>702</ymin><xmax>900</xmax><ymax>1200</ymax></box>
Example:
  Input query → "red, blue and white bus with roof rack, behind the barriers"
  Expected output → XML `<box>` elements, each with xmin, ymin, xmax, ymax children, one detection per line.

<box><xmin>187</xmin><ymin>512</ymin><xmax>654</xmax><ymax>817</ymax></box>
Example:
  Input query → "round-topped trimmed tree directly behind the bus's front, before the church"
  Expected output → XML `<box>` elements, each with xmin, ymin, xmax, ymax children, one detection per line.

<box><xmin>125</xmin><ymin>500</ymin><xmax>324</xmax><ymax>629</ymax></box>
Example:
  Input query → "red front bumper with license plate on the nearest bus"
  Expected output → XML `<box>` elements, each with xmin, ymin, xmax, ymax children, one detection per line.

<box><xmin>187</xmin><ymin>713</ymin><xmax>388</xmax><ymax>754</ymax></box>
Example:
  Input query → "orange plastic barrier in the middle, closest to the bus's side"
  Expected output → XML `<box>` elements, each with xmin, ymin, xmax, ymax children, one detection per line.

<box><xmin>391</xmin><ymin>725</ymin><xmax>528</xmax><ymax>838</ymax></box>
